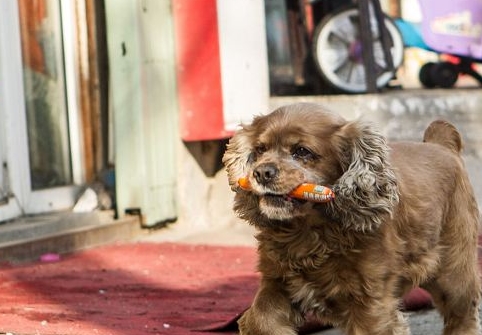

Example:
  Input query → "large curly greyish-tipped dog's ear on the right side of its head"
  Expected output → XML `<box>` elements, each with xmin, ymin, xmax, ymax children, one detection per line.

<box><xmin>330</xmin><ymin>121</ymin><xmax>399</xmax><ymax>231</ymax></box>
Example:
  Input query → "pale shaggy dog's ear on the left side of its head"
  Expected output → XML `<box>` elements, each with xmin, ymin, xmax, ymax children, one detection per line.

<box><xmin>223</xmin><ymin>126</ymin><xmax>252</xmax><ymax>190</ymax></box>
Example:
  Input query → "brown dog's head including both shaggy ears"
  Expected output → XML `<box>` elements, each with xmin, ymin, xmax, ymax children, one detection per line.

<box><xmin>223</xmin><ymin>103</ymin><xmax>398</xmax><ymax>230</ymax></box>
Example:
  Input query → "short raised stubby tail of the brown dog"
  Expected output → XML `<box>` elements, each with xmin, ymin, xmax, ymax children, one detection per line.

<box><xmin>423</xmin><ymin>120</ymin><xmax>462</xmax><ymax>154</ymax></box>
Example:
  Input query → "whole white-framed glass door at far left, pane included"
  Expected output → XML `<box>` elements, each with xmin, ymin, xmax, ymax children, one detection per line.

<box><xmin>0</xmin><ymin>0</ymin><xmax>82</xmax><ymax>221</ymax></box>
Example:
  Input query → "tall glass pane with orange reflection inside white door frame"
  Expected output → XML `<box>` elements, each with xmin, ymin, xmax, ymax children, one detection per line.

<box><xmin>18</xmin><ymin>0</ymin><xmax>72</xmax><ymax>190</ymax></box>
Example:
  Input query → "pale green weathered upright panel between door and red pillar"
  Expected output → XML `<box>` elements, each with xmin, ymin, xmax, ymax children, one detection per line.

<box><xmin>105</xmin><ymin>0</ymin><xmax>179</xmax><ymax>226</ymax></box>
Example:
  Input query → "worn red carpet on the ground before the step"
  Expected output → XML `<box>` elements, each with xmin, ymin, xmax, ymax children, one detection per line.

<box><xmin>0</xmin><ymin>244</ymin><xmax>440</xmax><ymax>335</ymax></box>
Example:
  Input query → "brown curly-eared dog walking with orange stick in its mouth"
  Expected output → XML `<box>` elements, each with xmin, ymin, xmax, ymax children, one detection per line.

<box><xmin>223</xmin><ymin>104</ymin><xmax>480</xmax><ymax>335</ymax></box>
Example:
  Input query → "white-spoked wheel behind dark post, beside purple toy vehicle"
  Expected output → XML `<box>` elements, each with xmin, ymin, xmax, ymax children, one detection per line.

<box><xmin>313</xmin><ymin>7</ymin><xmax>404</xmax><ymax>93</ymax></box>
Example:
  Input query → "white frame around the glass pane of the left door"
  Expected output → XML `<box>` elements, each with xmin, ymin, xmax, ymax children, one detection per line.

<box><xmin>0</xmin><ymin>0</ymin><xmax>84</xmax><ymax>221</ymax></box>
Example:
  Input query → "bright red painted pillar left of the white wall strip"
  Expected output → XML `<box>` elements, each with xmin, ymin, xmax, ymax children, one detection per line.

<box><xmin>173</xmin><ymin>0</ymin><xmax>229</xmax><ymax>141</ymax></box>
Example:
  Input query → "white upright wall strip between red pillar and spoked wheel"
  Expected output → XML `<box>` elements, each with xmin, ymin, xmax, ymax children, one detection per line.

<box><xmin>217</xmin><ymin>0</ymin><xmax>269</xmax><ymax>130</ymax></box>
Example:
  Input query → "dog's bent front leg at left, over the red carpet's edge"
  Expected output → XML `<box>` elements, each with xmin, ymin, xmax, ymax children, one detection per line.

<box><xmin>238</xmin><ymin>279</ymin><xmax>302</xmax><ymax>335</ymax></box>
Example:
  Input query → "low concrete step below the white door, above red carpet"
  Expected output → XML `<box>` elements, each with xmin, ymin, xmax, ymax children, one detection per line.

<box><xmin>0</xmin><ymin>212</ymin><xmax>144</xmax><ymax>263</ymax></box>
